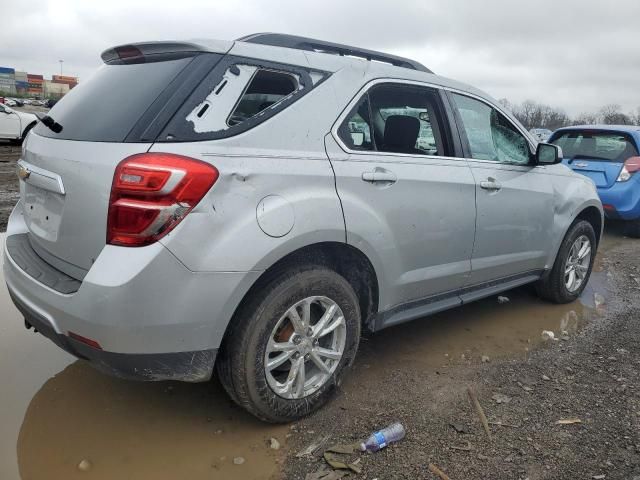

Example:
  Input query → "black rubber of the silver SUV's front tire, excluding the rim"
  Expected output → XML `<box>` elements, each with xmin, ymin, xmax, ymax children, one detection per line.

<box><xmin>536</xmin><ymin>220</ymin><xmax>596</xmax><ymax>303</ymax></box>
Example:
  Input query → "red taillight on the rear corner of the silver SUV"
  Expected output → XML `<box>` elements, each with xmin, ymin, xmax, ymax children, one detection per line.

<box><xmin>107</xmin><ymin>153</ymin><xmax>218</xmax><ymax>247</ymax></box>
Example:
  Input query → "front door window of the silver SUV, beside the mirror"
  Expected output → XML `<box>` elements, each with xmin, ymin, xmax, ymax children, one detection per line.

<box><xmin>453</xmin><ymin>94</ymin><xmax>531</xmax><ymax>164</ymax></box>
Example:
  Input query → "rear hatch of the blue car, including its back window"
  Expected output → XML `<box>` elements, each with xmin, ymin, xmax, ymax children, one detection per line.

<box><xmin>550</xmin><ymin>129</ymin><xmax>638</xmax><ymax>188</ymax></box>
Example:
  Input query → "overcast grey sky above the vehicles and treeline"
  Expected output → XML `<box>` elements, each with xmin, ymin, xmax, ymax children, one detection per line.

<box><xmin>0</xmin><ymin>0</ymin><xmax>640</xmax><ymax>115</ymax></box>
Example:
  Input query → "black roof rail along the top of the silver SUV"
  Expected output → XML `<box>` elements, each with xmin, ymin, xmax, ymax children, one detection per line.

<box><xmin>237</xmin><ymin>33</ymin><xmax>433</xmax><ymax>73</ymax></box>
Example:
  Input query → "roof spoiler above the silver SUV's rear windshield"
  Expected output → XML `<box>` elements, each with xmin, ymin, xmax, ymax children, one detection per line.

<box><xmin>100</xmin><ymin>42</ymin><xmax>208</xmax><ymax>65</ymax></box>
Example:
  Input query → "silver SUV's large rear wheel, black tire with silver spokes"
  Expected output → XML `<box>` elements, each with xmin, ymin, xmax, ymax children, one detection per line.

<box><xmin>216</xmin><ymin>266</ymin><xmax>361</xmax><ymax>423</ymax></box>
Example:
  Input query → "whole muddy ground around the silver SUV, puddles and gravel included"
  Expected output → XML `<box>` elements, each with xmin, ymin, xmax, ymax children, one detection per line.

<box><xmin>0</xmin><ymin>141</ymin><xmax>640</xmax><ymax>480</ymax></box>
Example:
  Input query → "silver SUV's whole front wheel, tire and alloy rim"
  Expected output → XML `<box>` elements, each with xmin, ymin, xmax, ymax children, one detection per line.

<box><xmin>536</xmin><ymin>220</ymin><xmax>596</xmax><ymax>303</ymax></box>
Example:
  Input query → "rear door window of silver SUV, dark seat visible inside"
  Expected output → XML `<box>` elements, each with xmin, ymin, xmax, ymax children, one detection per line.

<box><xmin>338</xmin><ymin>84</ymin><xmax>450</xmax><ymax>156</ymax></box>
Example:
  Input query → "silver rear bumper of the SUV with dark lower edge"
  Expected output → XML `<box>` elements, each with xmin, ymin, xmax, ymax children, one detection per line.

<box><xmin>3</xmin><ymin>205</ymin><xmax>260</xmax><ymax>382</ymax></box>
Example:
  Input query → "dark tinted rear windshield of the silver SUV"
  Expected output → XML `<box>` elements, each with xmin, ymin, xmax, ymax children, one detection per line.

<box><xmin>35</xmin><ymin>58</ymin><xmax>192</xmax><ymax>142</ymax></box>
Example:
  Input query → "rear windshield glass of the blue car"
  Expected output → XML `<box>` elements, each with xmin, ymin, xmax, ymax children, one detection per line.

<box><xmin>551</xmin><ymin>130</ymin><xmax>638</xmax><ymax>162</ymax></box>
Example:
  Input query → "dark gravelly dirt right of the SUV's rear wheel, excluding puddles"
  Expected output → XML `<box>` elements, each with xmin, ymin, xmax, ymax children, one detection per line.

<box><xmin>285</xmin><ymin>227</ymin><xmax>640</xmax><ymax>480</ymax></box>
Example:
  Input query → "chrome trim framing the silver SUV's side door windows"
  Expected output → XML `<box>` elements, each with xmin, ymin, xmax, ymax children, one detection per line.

<box><xmin>331</xmin><ymin>77</ymin><xmax>536</xmax><ymax>163</ymax></box>
